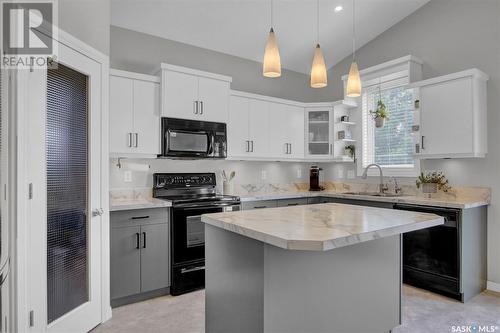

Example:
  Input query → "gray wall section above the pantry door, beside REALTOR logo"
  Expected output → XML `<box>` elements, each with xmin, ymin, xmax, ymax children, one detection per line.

<box><xmin>58</xmin><ymin>0</ymin><xmax>111</xmax><ymax>55</ymax></box>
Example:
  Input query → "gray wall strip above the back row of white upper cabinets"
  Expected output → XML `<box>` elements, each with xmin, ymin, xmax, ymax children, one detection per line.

<box><xmin>111</xmin><ymin>26</ymin><xmax>319</xmax><ymax>101</ymax></box>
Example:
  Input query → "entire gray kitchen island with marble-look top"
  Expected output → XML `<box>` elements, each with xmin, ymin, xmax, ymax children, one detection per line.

<box><xmin>202</xmin><ymin>203</ymin><xmax>444</xmax><ymax>333</ymax></box>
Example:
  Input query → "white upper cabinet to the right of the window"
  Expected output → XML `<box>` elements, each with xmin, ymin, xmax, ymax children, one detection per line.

<box><xmin>411</xmin><ymin>69</ymin><xmax>488</xmax><ymax>159</ymax></box>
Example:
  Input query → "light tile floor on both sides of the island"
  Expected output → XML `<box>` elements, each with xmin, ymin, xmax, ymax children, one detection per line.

<box><xmin>92</xmin><ymin>286</ymin><xmax>500</xmax><ymax>333</ymax></box>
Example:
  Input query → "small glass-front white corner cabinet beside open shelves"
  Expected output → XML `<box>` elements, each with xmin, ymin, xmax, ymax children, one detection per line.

<box><xmin>306</xmin><ymin>106</ymin><xmax>333</xmax><ymax>159</ymax></box>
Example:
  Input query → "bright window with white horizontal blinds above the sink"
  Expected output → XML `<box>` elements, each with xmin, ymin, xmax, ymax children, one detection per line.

<box><xmin>358</xmin><ymin>72</ymin><xmax>420</xmax><ymax>177</ymax></box>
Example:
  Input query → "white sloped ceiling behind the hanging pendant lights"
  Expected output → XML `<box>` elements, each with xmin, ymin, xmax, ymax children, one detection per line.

<box><xmin>111</xmin><ymin>0</ymin><xmax>429</xmax><ymax>73</ymax></box>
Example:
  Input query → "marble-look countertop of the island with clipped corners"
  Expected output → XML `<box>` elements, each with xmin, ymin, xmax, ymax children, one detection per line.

<box><xmin>201</xmin><ymin>203</ymin><xmax>444</xmax><ymax>251</ymax></box>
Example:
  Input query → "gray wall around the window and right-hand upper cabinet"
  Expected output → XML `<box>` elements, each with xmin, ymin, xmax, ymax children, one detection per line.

<box><xmin>321</xmin><ymin>0</ymin><xmax>500</xmax><ymax>283</ymax></box>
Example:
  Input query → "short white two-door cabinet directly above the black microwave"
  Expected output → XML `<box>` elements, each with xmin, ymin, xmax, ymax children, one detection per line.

<box><xmin>161</xmin><ymin>64</ymin><xmax>232</xmax><ymax>123</ymax></box>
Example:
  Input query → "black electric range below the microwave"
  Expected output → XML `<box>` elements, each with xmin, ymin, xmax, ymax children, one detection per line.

<box><xmin>153</xmin><ymin>173</ymin><xmax>240</xmax><ymax>295</ymax></box>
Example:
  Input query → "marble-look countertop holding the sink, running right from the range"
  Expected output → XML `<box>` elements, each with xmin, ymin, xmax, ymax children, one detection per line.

<box><xmin>240</xmin><ymin>191</ymin><xmax>490</xmax><ymax>209</ymax></box>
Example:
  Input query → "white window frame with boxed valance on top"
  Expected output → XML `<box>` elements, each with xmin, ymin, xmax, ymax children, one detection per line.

<box><xmin>343</xmin><ymin>55</ymin><xmax>423</xmax><ymax>177</ymax></box>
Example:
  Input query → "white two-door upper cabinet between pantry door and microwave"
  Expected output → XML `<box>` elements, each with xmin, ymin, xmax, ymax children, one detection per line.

<box><xmin>109</xmin><ymin>69</ymin><xmax>160</xmax><ymax>157</ymax></box>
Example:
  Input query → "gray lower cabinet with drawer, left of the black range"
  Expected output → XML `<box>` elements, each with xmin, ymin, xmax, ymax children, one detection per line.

<box><xmin>110</xmin><ymin>208</ymin><xmax>170</xmax><ymax>306</ymax></box>
